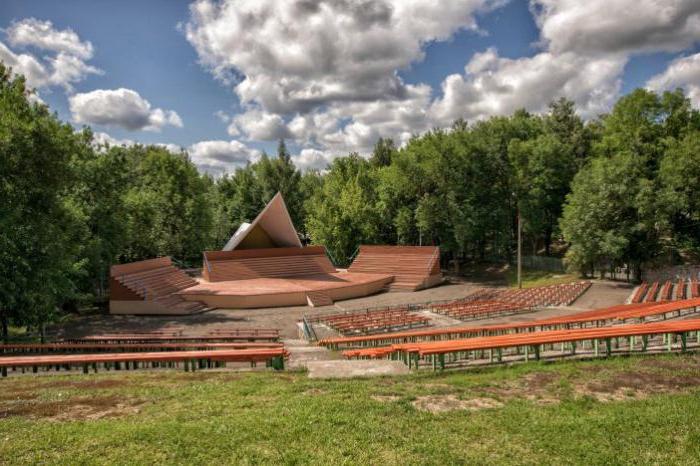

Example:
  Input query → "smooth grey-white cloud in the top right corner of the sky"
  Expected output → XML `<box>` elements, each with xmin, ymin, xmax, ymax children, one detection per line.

<box><xmin>531</xmin><ymin>0</ymin><xmax>700</xmax><ymax>55</ymax></box>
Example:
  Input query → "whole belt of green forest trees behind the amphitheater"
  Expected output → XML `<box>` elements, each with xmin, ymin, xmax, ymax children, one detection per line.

<box><xmin>0</xmin><ymin>64</ymin><xmax>700</xmax><ymax>334</ymax></box>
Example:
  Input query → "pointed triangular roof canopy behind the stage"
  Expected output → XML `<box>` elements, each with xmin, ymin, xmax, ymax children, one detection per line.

<box><xmin>223</xmin><ymin>193</ymin><xmax>301</xmax><ymax>251</ymax></box>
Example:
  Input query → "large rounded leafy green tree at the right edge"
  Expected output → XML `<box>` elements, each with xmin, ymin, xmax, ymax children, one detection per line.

<box><xmin>561</xmin><ymin>89</ymin><xmax>700</xmax><ymax>278</ymax></box>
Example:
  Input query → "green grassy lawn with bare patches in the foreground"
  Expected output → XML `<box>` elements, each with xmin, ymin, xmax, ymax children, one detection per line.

<box><xmin>0</xmin><ymin>355</ymin><xmax>700</xmax><ymax>465</ymax></box>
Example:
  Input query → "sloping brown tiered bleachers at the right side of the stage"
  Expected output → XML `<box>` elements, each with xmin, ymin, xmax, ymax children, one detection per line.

<box><xmin>348</xmin><ymin>246</ymin><xmax>442</xmax><ymax>291</ymax></box>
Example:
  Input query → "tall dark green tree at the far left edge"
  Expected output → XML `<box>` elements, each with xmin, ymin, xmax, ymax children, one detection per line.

<box><xmin>0</xmin><ymin>64</ymin><xmax>86</xmax><ymax>341</ymax></box>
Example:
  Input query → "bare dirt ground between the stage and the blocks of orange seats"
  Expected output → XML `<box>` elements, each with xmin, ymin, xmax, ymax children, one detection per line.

<box><xmin>50</xmin><ymin>281</ymin><xmax>632</xmax><ymax>338</ymax></box>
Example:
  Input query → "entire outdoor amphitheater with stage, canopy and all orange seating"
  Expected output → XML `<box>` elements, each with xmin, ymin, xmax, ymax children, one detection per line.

<box><xmin>0</xmin><ymin>194</ymin><xmax>700</xmax><ymax>377</ymax></box>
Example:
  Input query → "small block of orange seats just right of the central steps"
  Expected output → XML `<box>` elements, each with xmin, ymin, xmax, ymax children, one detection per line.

<box><xmin>307</xmin><ymin>308</ymin><xmax>430</xmax><ymax>335</ymax></box>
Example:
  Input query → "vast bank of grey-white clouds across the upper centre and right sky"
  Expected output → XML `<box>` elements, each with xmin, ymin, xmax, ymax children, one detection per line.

<box><xmin>183</xmin><ymin>0</ymin><xmax>700</xmax><ymax>160</ymax></box>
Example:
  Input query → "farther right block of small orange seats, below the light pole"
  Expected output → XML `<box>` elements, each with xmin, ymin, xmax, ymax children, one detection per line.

<box><xmin>463</xmin><ymin>281</ymin><xmax>591</xmax><ymax>306</ymax></box>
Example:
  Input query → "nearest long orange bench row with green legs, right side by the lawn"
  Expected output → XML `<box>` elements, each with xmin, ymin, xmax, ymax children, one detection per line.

<box><xmin>344</xmin><ymin>319</ymin><xmax>700</xmax><ymax>369</ymax></box>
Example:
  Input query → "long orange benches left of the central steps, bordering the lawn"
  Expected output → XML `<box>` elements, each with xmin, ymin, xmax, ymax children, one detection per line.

<box><xmin>0</xmin><ymin>329</ymin><xmax>289</xmax><ymax>377</ymax></box>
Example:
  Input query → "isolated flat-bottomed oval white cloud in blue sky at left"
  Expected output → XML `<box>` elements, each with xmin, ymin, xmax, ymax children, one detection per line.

<box><xmin>68</xmin><ymin>88</ymin><xmax>182</xmax><ymax>131</ymax></box>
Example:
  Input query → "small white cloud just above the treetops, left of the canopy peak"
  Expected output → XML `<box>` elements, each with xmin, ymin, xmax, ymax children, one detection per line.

<box><xmin>187</xmin><ymin>140</ymin><xmax>260</xmax><ymax>176</ymax></box>
